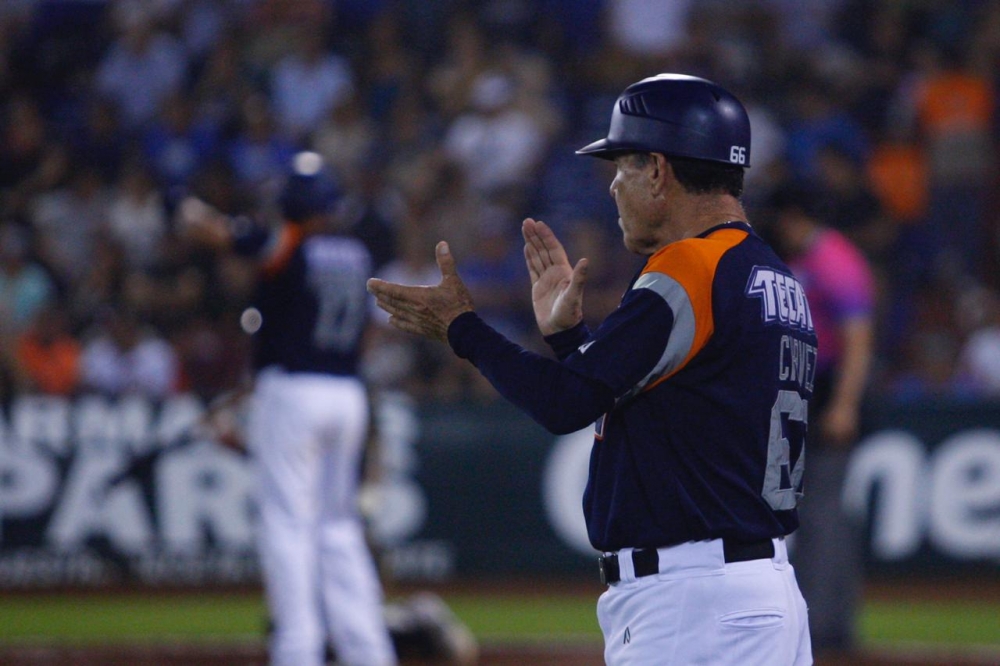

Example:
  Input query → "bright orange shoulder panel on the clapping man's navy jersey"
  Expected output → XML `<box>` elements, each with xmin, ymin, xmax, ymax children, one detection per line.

<box><xmin>642</xmin><ymin>229</ymin><xmax>747</xmax><ymax>391</ymax></box>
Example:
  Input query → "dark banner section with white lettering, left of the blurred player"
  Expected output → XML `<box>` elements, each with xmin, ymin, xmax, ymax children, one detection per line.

<box><xmin>0</xmin><ymin>396</ymin><xmax>258</xmax><ymax>587</ymax></box>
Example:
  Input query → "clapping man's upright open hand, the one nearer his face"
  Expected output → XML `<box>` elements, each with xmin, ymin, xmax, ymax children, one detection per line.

<box><xmin>521</xmin><ymin>217</ymin><xmax>587</xmax><ymax>335</ymax></box>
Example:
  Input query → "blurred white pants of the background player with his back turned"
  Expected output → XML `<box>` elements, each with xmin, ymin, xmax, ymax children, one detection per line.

<box><xmin>249</xmin><ymin>369</ymin><xmax>396</xmax><ymax>666</ymax></box>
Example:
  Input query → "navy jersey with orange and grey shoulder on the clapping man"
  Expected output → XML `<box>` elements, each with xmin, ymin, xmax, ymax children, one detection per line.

<box><xmin>449</xmin><ymin>223</ymin><xmax>817</xmax><ymax>551</ymax></box>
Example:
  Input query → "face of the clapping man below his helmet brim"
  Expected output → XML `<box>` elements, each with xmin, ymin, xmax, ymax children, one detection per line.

<box><xmin>611</xmin><ymin>153</ymin><xmax>661</xmax><ymax>255</ymax></box>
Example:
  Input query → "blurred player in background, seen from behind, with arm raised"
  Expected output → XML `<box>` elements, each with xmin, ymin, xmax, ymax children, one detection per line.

<box><xmin>182</xmin><ymin>152</ymin><xmax>397</xmax><ymax>666</ymax></box>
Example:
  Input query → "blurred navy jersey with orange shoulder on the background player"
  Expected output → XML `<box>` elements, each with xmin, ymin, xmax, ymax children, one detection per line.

<box><xmin>237</xmin><ymin>224</ymin><xmax>372</xmax><ymax>375</ymax></box>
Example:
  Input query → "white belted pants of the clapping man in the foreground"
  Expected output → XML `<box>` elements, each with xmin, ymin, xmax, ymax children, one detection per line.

<box><xmin>597</xmin><ymin>539</ymin><xmax>812</xmax><ymax>666</ymax></box>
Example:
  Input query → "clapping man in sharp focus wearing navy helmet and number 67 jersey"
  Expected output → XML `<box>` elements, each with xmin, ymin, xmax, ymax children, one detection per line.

<box><xmin>368</xmin><ymin>74</ymin><xmax>817</xmax><ymax>666</ymax></box>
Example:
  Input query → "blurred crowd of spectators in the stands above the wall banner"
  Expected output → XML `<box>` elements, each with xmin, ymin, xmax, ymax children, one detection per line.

<box><xmin>0</xmin><ymin>0</ymin><xmax>1000</xmax><ymax>400</ymax></box>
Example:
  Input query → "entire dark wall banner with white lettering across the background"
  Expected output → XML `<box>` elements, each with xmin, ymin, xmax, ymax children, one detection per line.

<box><xmin>0</xmin><ymin>395</ymin><xmax>1000</xmax><ymax>588</ymax></box>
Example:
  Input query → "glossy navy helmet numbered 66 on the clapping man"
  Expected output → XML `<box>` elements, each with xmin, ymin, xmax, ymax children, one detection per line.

<box><xmin>576</xmin><ymin>74</ymin><xmax>750</xmax><ymax>167</ymax></box>
